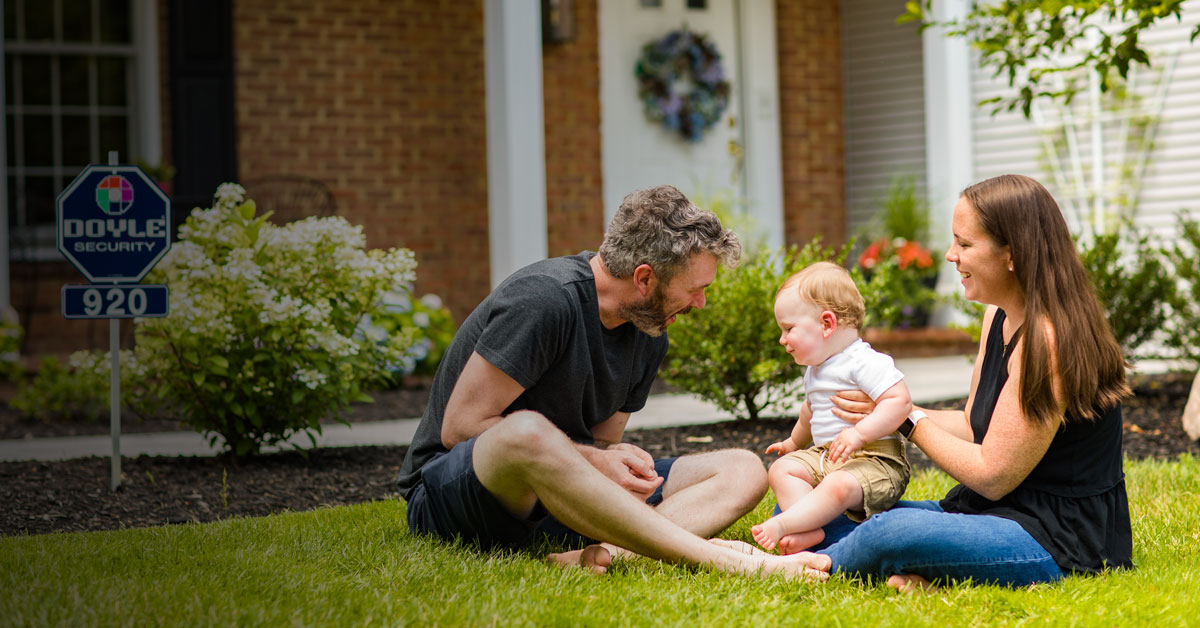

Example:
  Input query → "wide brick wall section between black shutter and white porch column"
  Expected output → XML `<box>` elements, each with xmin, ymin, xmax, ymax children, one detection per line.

<box><xmin>234</xmin><ymin>0</ymin><xmax>490</xmax><ymax>319</ymax></box>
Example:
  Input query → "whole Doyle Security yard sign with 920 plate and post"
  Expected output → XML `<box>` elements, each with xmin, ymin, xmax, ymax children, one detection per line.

<box><xmin>55</xmin><ymin>151</ymin><xmax>170</xmax><ymax>490</ymax></box>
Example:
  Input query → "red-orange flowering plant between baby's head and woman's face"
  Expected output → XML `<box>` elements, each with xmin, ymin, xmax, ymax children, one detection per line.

<box><xmin>858</xmin><ymin>238</ymin><xmax>938</xmax><ymax>329</ymax></box>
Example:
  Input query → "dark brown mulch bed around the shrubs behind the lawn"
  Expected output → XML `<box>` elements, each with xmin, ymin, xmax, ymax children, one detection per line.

<box><xmin>0</xmin><ymin>375</ymin><xmax>1200</xmax><ymax>536</ymax></box>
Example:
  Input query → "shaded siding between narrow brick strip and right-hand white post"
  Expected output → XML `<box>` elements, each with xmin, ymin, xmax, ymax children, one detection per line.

<box><xmin>841</xmin><ymin>0</ymin><xmax>925</xmax><ymax>235</ymax></box>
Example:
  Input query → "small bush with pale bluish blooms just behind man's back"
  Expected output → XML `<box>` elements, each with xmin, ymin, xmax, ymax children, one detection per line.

<box><xmin>360</xmin><ymin>287</ymin><xmax>458</xmax><ymax>377</ymax></box>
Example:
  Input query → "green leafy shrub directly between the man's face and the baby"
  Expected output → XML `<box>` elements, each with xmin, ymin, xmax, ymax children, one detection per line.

<box><xmin>662</xmin><ymin>239</ymin><xmax>847</xmax><ymax>419</ymax></box>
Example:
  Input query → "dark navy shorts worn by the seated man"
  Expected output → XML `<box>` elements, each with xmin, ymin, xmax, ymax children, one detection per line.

<box><xmin>407</xmin><ymin>438</ymin><xmax>676</xmax><ymax>549</ymax></box>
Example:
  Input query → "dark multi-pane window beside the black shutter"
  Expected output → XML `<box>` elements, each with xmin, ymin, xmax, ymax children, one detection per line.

<box><xmin>4</xmin><ymin>0</ymin><xmax>140</xmax><ymax>259</ymax></box>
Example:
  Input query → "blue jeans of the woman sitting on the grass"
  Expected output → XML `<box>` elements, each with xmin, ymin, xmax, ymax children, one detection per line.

<box><xmin>815</xmin><ymin>501</ymin><xmax>1064</xmax><ymax>587</ymax></box>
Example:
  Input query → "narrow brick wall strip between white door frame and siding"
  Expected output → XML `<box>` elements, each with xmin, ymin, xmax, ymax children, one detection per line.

<box><xmin>775</xmin><ymin>0</ymin><xmax>846</xmax><ymax>245</ymax></box>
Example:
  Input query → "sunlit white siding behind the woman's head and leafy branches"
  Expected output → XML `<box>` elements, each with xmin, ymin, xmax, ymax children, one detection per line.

<box><xmin>972</xmin><ymin>0</ymin><xmax>1200</xmax><ymax>237</ymax></box>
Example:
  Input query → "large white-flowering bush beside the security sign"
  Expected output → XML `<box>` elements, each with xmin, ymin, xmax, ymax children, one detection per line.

<box><xmin>137</xmin><ymin>184</ymin><xmax>416</xmax><ymax>455</ymax></box>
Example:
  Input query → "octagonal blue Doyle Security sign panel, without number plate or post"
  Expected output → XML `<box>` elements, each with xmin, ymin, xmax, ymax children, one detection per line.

<box><xmin>55</xmin><ymin>163</ymin><xmax>170</xmax><ymax>283</ymax></box>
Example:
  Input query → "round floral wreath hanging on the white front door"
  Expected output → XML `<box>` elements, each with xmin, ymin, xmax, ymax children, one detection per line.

<box><xmin>634</xmin><ymin>29</ymin><xmax>730</xmax><ymax>142</ymax></box>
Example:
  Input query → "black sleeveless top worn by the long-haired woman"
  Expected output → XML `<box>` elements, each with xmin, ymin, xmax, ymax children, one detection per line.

<box><xmin>941</xmin><ymin>310</ymin><xmax>1133</xmax><ymax>573</ymax></box>
